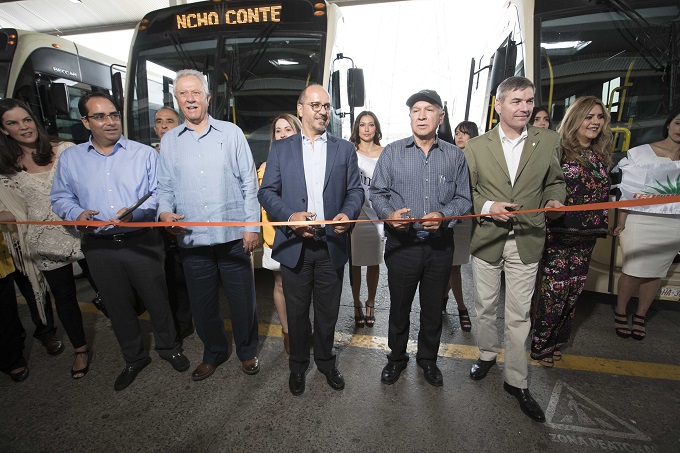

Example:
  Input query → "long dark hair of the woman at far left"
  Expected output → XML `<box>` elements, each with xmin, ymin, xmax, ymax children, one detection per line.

<box><xmin>0</xmin><ymin>98</ymin><xmax>54</xmax><ymax>175</ymax></box>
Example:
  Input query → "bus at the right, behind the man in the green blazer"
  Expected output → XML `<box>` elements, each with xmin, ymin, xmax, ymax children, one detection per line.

<box><xmin>466</xmin><ymin>0</ymin><xmax>680</xmax><ymax>293</ymax></box>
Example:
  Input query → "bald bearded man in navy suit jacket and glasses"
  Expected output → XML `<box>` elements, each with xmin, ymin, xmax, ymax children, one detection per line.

<box><xmin>257</xmin><ymin>85</ymin><xmax>364</xmax><ymax>395</ymax></box>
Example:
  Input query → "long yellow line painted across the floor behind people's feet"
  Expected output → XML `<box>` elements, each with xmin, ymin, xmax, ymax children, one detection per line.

<box><xmin>17</xmin><ymin>296</ymin><xmax>680</xmax><ymax>381</ymax></box>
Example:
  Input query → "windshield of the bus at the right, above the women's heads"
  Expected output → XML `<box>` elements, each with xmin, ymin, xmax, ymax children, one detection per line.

<box><xmin>537</xmin><ymin>5</ymin><xmax>680</xmax><ymax>150</ymax></box>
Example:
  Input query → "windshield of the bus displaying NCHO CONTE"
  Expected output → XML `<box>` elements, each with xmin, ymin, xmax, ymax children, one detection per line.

<box><xmin>128</xmin><ymin>33</ymin><xmax>324</xmax><ymax>162</ymax></box>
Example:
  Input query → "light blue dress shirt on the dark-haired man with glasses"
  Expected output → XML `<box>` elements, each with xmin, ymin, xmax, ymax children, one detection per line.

<box><xmin>50</xmin><ymin>136</ymin><xmax>158</xmax><ymax>234</ymax></box>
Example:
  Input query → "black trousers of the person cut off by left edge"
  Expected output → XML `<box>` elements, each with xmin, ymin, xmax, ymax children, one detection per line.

<box><xmin>0</xmin><ymin>274</ymin><xmax>26</xmax><ymax>373</ymax></box>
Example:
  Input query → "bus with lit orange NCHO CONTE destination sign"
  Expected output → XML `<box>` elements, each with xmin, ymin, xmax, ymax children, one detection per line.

<box><xmin>125</xmin><ymin>0</ymin><xmax>364</xmax><ymax>160</ymax></box>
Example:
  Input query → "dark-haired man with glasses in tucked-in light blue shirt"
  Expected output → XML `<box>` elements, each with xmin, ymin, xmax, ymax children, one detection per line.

<box><xmin>50</xmin><ymin>92</ymin><xmax>190</xmax><ymax>390</ymax></box>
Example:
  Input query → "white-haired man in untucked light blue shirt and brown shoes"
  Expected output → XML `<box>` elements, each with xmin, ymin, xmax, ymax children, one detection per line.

<box><xmin>158</xmin><ymin>69</ymin><xmax>260</xmax><ymax>381</ymax></box>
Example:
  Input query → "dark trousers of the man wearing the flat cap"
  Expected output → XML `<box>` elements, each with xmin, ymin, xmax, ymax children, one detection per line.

<box><xmin>385</xmin><ymin>229</ymin><xmax>453</xmax><ymax>366</ymax></box>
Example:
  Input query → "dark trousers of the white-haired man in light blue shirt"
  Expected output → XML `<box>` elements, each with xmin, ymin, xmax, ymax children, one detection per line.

<box><xmin>180</xmin><ymin>239</ymin><xmax>258</xmax><ymax>366</ymax></box>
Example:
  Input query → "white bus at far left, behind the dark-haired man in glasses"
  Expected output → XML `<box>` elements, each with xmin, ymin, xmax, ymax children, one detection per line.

<box><xmin>0</xmin><ymin>28</ymin><xmax>125</xmax><ymax>143</ymax></box>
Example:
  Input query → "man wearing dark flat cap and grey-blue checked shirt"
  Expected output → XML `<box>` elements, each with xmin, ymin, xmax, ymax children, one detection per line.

<box><xmin>370</xmin><ymin>90</ymin><xmax>472</xmax><ymax>387</ymax></box>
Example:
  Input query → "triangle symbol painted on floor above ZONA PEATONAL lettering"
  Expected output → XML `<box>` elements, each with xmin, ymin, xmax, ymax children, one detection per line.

<box><xmin>545</xmin><ymin>381</ymin><xmax>651</xmax><ymax>441</ymax></box>
